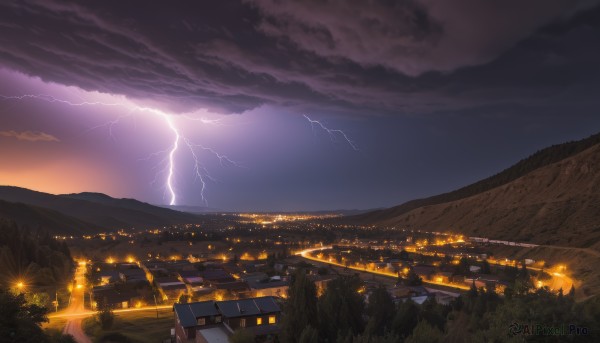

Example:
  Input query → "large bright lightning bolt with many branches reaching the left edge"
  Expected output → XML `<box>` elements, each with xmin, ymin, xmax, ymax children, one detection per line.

<box><xmin>0</xmin><ymin>94</ymin><xmax>242</xmax><ymax>206</ymax></box>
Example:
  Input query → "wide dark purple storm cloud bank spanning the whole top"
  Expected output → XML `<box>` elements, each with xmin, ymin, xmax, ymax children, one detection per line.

<box><xmin>0</xmin><ymin>0</ymin><xmax>598</xmax><ymax>114</ymax></box>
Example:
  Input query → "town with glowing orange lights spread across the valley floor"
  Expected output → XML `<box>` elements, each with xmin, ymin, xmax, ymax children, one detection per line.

<box><xmin>35</xmin><ymin>214</ymin><xmax>574</xmax><ymax>342</ymax></box>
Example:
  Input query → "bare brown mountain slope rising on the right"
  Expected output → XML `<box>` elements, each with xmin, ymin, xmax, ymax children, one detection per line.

<box><xmin>351</xmin><ymin>134</ymin><xmax>600</xmax><ymax>248</ymax></box>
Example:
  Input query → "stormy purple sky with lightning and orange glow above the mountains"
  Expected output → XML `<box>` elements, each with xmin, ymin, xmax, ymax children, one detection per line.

<box><xmin>0</xmin><ymin>0</ymin><xmax>600</xmax><ymax>211</ymax></box>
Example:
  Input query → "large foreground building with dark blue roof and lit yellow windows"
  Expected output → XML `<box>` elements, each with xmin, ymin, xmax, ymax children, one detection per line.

<box><xmin>173</xmin><ymin>297</ymin><xmax>281</xmax><ymax>343</ymax></box>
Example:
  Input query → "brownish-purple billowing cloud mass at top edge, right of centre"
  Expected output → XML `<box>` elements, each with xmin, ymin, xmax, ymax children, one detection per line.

<box><xmin>246</xmin><ymin>0</ymin><xmax>586</xmax><ymax>76</ymax></box>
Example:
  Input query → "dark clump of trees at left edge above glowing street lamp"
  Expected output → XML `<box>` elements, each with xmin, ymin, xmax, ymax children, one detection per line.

<box><xmin>0</xmin><ymin>220</ymin><xmax>73</xmax><ymax>291</ymax></box>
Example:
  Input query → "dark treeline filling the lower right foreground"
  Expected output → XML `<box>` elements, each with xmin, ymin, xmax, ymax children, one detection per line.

<box><xmin>279</xmin><ymin>272</ymin><xmax>600</xmax><ymax>343</ymax></box>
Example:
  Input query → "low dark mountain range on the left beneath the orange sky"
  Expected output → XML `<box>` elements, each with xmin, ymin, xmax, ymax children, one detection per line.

<box><xmin>0</xmin><ymin>186</ymin><xmax>198</xmax><ymax>233</ymax></box>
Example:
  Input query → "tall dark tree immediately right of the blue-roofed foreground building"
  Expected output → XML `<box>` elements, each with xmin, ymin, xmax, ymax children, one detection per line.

<box><xmin>281</xmin><ymin>269</ymin><xmax>317</xmax><ymax>343</ymax></box>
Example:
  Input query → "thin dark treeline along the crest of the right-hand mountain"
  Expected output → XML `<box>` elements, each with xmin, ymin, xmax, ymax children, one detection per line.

<box><xmin>364</xmin><ymin>133</ymin><xmax>600</xmax><ymax>222</ymax></box>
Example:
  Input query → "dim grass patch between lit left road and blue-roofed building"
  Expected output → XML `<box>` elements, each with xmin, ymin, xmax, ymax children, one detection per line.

<box><xmin>82</xmin><ymin>309</ymin><xmax>173</xmax><ymax>343</ymax></box>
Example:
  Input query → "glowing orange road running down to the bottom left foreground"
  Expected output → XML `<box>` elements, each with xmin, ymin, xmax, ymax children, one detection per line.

<box><xmin>61</xmin><ymin>264</ymin><xmax>92</xmax><ymax>343</ymax></box>
